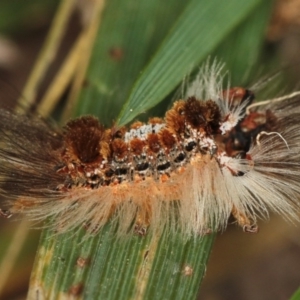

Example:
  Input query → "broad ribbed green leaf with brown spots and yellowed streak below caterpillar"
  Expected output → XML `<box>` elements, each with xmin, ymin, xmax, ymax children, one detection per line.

<box><xmin>29</xmin><ymin>226</ymin><xmax>214</xmax><ymax>299</ymax></box>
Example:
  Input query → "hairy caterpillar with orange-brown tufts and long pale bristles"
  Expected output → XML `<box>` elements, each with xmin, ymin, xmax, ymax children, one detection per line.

<box><xmin>0</xmin><ymin>63</ymin><xmax>300</xmax><ymax>236</ymax></box>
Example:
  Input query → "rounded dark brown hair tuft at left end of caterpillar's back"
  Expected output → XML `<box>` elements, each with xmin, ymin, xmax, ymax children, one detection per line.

<box><xmin>64</xmin><ymin>116</ymin><xmax>105</xmax><ymax>163</ymax></box>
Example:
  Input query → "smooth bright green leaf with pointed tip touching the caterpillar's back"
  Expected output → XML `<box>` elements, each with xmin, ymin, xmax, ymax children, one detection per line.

<box><xmin>117</xmin><ymin>0</ymin><xmax>268</xmax><ymax>126</ymax></box>
